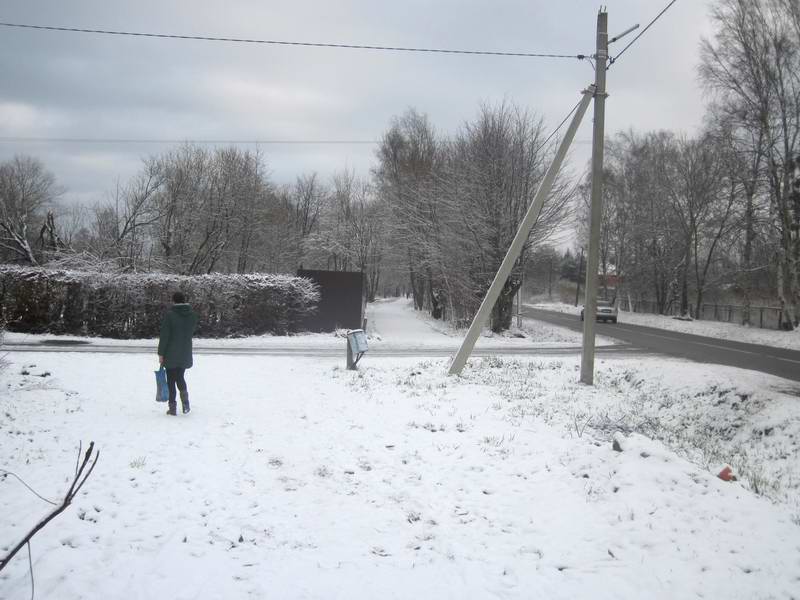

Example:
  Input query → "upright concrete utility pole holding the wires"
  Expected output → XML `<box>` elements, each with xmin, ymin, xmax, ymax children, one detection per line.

<box><xmin>581</xmin><ymin>9</ymin><xmax>608</xmax><ymax>385</ymax></box>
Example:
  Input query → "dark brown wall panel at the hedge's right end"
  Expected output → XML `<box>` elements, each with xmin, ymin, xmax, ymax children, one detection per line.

<box><xmin>297</xmin><ymin>269</ymin><xmax>364</xmax><ymax>331</ymax></box>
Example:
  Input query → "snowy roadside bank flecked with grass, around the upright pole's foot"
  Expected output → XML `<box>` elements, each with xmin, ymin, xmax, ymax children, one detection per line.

<box><xmin>456</xmin><ymin>358</ymin><xmax>800</xmax><ymax>510</ymax></box>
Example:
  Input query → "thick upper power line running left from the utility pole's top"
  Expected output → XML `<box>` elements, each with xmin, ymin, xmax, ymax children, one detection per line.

<box><xmin>0</xmin><ymin>22</ymin><xmax>586</xmax><ymax>60</ymax></box>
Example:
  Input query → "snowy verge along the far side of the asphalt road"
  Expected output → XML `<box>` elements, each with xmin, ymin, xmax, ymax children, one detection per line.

<box><xmin>525</xmin><ymin>302</ymin><xmax>800</xmax><ymax>350</ymax></box>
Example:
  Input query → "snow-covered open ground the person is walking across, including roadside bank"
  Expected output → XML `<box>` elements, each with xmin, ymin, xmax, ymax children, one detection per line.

<box><xmin>0</xmin><ymin>302</ymin><xmax>800</xmax><ymax>600</ymax></box>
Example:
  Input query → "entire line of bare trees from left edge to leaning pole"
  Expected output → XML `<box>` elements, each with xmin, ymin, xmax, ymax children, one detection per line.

<box><xmin>0</xmin><ymin>103</ymin><xmax>574</xmax><ymax>329</ymax></box>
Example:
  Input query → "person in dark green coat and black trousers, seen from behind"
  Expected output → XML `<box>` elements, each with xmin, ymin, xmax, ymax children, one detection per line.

<box><xmin>158</xmin><ymin>292</ymin><xmax>197</xmax><ymax>415</ymax></box>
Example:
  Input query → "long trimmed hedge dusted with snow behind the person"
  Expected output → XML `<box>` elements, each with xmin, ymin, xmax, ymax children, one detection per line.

<box><xmin>0</xmin><ymin>266</ymin><xmax>319</xmax><ymax>339</ymax></box>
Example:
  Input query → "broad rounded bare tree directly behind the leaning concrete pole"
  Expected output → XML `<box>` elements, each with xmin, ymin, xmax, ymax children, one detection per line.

<box><xmin>442</xmin><ymin>103</ymin><xmax>575</xmax><ymax>331</ymax></box>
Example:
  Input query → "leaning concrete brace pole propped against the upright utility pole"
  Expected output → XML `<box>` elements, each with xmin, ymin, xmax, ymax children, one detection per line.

<box><xmin>450</xmin><ymin>86</ymin><xmax>594</xmax><ymax>375</ymax></box>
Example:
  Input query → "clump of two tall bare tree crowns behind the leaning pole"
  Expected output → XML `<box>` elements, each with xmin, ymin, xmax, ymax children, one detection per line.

<box><xmin>375</xmin><ymin>103</ymin><xmax>575</xmax><ymax>331</ymax></box>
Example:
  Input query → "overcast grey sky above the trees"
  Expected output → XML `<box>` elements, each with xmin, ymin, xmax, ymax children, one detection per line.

<box><xmin>0</xmin><ymin>0</ymin><xmax>711</xmax><ymax>203</ymax></box>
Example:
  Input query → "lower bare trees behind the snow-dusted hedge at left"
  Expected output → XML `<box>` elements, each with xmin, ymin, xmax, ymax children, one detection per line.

<box><xmin>0</xmin><ymin>149</ymin><xmax>386</xmax><ymax>282</ymax></box>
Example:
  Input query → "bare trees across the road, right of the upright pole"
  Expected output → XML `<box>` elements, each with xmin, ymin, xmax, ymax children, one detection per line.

<box><xmin>579</xmin><ymin>0</ymin><xmax>800</xmax><ymax>327</ymax></box>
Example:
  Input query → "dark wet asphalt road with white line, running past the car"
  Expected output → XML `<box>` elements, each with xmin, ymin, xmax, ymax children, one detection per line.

<box><xmin>523</xmin><ymin>307</ymin><xmax>800</xmax><ymax>381</ymax></box>
